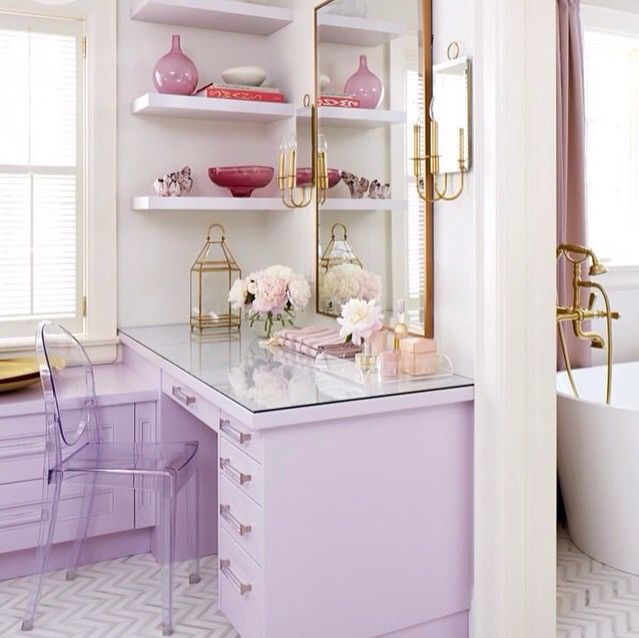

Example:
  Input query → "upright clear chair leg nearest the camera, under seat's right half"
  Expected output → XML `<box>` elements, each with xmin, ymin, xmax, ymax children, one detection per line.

<box><xmin>160</xmin><ymin>473</ymin><xmax>177</xmax><ymax>636</ymax></box>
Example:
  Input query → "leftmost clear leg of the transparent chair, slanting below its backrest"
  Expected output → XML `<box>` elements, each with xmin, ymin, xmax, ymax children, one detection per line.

<box><xmin>21</xmin><ymin>472</ymin><xmax>62</xmax><ymax>631</ymax></box>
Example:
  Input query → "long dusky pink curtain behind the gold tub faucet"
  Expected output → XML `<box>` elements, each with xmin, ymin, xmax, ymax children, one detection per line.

<box><xmin>557</xmin><ymin>0</ymin><xmax>590</xmax><ymax>368</ymax></box>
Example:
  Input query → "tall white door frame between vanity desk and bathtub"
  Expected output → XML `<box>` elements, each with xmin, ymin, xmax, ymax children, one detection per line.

<box><xmin>472</xmin><ymin>0</ymin><xmax>556</xmax><ymax>638</ymax></box>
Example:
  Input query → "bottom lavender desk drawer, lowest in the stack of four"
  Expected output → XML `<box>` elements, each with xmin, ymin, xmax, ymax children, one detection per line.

<box><xmin>218</xmin><ymin>531</ymin><xmax>264</xmax><ymax>638</ymax></box>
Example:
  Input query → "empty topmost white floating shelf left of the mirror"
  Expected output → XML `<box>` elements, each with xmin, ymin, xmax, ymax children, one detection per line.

<box><xmin>131</xmin><ymin>0</ymin><xmax>293</xmax><ymax>35</ymax></box>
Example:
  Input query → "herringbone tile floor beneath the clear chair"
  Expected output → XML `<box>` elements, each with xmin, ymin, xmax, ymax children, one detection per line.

<box><xmin>0</xmin><ymin>554</ymin><xmax>239</xmax><ymax>638</ymax></box>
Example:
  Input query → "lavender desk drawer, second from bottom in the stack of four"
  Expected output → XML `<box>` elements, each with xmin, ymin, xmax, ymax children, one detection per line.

<box><xmin>219</xmin><ymin>476</ymin><xmax>264</xmax><ymax>565</ymax></box>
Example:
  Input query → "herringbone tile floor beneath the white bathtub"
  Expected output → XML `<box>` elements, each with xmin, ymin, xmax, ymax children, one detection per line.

<box><xmin>557</xmin><ymin>530</ymin><xmax>639</xmax><ymax>638</ymax></box>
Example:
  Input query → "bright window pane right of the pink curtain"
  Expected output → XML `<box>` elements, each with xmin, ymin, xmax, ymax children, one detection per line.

<box><xmin>584</xmin><ymin>31</ymin><xmax>639</xmax><ymax>265</ymax></box>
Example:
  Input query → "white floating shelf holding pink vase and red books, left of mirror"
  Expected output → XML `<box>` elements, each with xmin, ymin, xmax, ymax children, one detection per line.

<box><xmin>131</xmin><ymin>93</ymin><xmax>295</xmax><ymax>122</ymax></box>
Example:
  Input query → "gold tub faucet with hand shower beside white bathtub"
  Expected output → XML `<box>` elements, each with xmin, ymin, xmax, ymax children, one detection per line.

<box><xmin>557</xmin><ymin>244</ymin><xmax>619</xmax><ymax>403</ymax></box>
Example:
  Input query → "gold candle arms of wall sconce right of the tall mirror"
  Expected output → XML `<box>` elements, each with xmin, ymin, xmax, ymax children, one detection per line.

<box><xmin>412</xmin><ymin>118</ymin><xmax>467</xmax><ymax>202</ymax></box>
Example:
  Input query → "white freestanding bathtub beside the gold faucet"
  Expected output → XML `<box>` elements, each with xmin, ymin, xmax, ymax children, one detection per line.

<box><xmin>557</xmin><ymin>362</ymin><xmax>639</xmax><ymax>574</ymax></box>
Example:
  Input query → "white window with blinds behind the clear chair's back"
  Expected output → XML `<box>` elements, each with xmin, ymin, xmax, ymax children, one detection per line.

<box><xmin>0</xmin><ymin>13</ymin><xmax>84</xmax><ymax>338</ymax></box>
